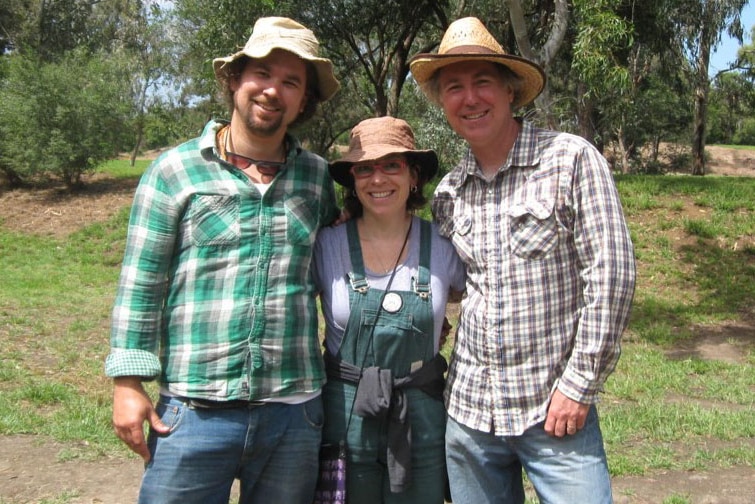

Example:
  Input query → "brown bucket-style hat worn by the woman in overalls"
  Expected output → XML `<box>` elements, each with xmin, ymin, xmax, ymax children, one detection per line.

<box><xmin>330</xmin><ymin>116</ymin><xmax>438</xmax><ymax>187</ymax></box>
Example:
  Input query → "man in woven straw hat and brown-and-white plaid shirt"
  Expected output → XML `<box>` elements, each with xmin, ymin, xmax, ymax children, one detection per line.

<box><xmin>411</xmin><ymin>18</ymin><xmax>635</xmax><ymax>504</ymax></box>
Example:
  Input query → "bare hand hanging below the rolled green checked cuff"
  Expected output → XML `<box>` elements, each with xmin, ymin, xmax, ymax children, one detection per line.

<box><xmin>113</xmin><ymin>376</ymin><xmax>170</xmax><ymax>462</ymax></box>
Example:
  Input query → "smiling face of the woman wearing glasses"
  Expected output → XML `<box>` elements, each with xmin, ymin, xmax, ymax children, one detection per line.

<box><xmin>352</xmin><ymin>155</ymin><xmax>417</xmax><ymax>216</ymax></box>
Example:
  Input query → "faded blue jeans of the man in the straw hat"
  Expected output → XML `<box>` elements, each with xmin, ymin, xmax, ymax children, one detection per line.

<box><xmin>446</xmin><ymin>406</ymin><xmax>613</xmax><ymax>504</ymax></box>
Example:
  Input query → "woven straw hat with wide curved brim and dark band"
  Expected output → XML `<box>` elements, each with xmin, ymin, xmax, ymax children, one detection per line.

<box><xmin>409</xmin><ymin>17</ymin><xmax>545</xmax><ymax>107</ymax></box>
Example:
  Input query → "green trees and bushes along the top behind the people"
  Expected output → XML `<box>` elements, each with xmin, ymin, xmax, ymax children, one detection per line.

<box><xmin>0</xmin><ymin>0</ymin><xmax>755</xmax><ymax>188</ymax></box>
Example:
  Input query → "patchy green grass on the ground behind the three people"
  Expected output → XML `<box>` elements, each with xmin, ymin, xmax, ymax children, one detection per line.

<box><xmin>0</xmin><ymin>161</ymin><xmax>755</xmax><ymax>503</ymax></box>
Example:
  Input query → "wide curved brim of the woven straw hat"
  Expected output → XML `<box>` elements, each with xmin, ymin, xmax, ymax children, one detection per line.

<box><xmin>409</xmin><ymin>53</ymin><xmax>545</xmax><ymax>107</ymax></box>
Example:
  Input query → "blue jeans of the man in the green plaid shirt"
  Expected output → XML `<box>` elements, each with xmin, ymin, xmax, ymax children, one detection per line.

<box><xmin>139</xmin><ymin>397</ymin><xmax>323</xmax><ymax>504</ymax></box>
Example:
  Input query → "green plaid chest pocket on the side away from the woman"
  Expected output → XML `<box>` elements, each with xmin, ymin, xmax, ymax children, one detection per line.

<box><xmin>189</xmin><ymin>194</ymin><xmax>241</xmax><ymax>247</ymax></box>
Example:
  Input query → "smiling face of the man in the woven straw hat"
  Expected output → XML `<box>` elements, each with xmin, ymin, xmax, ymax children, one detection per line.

<box><xmin>438</xmin><ymin>61</ymin><xmax>514</xmax><ymax>151</ymax></box>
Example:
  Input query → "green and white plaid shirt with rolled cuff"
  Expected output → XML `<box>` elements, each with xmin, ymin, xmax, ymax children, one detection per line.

<box><xmin>105</xmin><ymin>121</ymin><xmax>338</xmax><ymax>400</ymax></box>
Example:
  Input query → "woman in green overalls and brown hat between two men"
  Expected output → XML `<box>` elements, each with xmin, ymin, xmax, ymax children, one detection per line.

<box><xmin>314</xmin><ymin>117</ymin><xmax>465</xmax><ymax>504</ymax></box>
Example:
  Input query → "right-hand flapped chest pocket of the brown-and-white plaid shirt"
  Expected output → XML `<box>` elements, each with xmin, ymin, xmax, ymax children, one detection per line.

<box><xmin>506</xmin><ymin>199</ymin><xmax>558</xmax><ymax>260</ymax></box>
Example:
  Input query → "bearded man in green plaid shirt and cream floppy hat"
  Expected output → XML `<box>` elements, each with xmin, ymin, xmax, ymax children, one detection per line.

<box><xmin>106</xmin><ymin>17</ymin><xmax>338</xmax><ymax>504</ymax></box>
